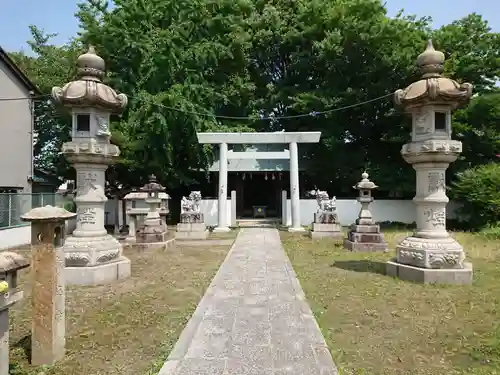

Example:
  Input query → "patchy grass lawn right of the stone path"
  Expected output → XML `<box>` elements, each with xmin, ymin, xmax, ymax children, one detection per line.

<box><xmin>281</xmin><ymin>231</ymin><xmax>500</xmax><ymax>375</ymax></box>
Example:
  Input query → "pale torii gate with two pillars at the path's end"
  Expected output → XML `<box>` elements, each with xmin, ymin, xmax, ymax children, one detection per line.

<box><xmin>196</xmin><ymin>132</ymin><xmax>321</xmax><ymax>232</ymax></box>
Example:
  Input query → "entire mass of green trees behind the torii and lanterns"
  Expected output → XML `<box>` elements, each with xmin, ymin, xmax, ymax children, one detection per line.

<box><xmin>16</xmin><ymin>0</ymin><xmax>500</xmax><ymax>195</ymax></box>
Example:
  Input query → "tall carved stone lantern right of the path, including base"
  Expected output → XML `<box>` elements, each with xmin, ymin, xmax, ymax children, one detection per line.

<box><xmin>387</xmin><ymin>41</ymin><xmax>472</xmax><ymax>284</ymax></box>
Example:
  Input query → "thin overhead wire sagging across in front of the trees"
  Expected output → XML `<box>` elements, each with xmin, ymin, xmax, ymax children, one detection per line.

<box><xmin>0</xmin><ymin>93</ymin><xmax>393</xmax><ymax>121</ymax></box>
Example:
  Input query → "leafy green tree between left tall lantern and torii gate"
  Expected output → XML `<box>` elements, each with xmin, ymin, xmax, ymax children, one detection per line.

<box><xmin>78</xmin><ymin>0</ymin><xmax>260</xmax><ymax>188</ymax></box>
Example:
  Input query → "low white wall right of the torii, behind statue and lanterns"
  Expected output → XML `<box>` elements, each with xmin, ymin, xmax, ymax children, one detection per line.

<box><xmin>286</xmin><ymin>199</ymin><xmax>459</xmax><ymax>226</ymax></box>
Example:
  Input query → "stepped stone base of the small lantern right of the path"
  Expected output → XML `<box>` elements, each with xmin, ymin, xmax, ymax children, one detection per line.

<box><xmin>344</xmin><ymin>224</ymin><xmax>387</xmax><ymax>251</ymax></box>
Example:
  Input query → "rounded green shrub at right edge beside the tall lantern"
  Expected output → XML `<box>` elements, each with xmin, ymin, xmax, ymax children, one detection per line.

<box><xmin>450</xmin><ymin>163</ymin><xmax>500</xmax><ymax>229</ymax></box>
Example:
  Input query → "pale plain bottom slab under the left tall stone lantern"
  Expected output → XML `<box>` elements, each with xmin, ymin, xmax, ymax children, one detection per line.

<box><xmin>64</xmin><ymin>256</ymin><xmax>131</xmax><ymax>286</ymax></box>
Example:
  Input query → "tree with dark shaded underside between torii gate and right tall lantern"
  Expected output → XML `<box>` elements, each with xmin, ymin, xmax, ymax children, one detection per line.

<box><xmin>240</xmin><ymin>0</ymin><xmax>429</xmax><ymax>194</ymax></box>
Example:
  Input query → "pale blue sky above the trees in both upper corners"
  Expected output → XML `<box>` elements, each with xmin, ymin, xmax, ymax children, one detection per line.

<box><xmin>0</xmin><ymin>0</ymin><xmax>500</xmax><ymax>51</ymax></box>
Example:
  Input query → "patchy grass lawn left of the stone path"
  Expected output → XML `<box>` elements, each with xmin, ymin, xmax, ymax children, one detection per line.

<box><xmin>10</xmin><ymin>244</ymin><xmax>229</xmax><ymax>375</ymax></box>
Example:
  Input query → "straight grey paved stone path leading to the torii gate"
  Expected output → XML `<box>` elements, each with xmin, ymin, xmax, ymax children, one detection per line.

<box><xmin>159</xmin><ymin>228</ymin><xmax>338</xmax><ymax>375</ymax></box>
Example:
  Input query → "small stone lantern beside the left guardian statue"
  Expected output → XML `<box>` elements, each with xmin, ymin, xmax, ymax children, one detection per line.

<box><xmin>136</xmin><ymin>175</ymin><xmax>167</xmax><ymax>244</ymax></box>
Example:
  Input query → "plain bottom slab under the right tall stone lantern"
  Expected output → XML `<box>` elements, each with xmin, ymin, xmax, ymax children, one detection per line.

<box><xmin>386</xmin><ymin>259</ymin><xmax>473</xmax><ymax>285</ymax></box>
